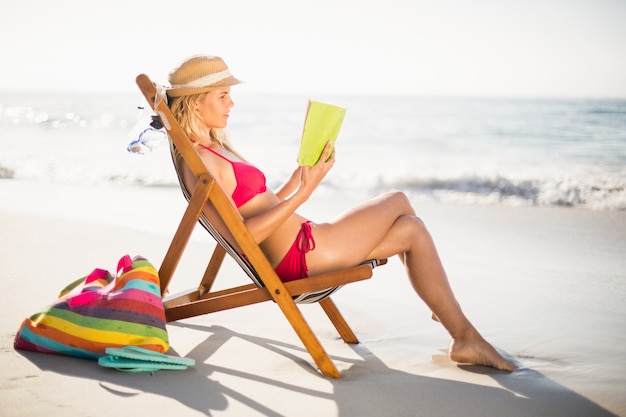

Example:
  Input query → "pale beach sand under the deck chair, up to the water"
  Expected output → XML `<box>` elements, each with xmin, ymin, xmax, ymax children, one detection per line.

<box><xmin>0</xmin><ymin>180</ymin><xmax>626</xmax><ymax>417</ymax></box>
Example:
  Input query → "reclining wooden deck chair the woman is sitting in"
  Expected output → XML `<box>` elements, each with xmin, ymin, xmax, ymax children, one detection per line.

<box><xmin>136</xmin><ymin>74</ymin><xmax>387</xmax><ymax>378</ymax></box>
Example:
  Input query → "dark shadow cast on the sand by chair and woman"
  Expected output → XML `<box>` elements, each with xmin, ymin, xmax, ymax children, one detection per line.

<box><xmin>22</xmin><ymin>322</ymin><xmax>616</xmax><ymax>417</ymax></box>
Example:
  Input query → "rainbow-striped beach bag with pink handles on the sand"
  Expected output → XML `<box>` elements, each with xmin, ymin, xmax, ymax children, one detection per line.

<box><xmin>14</xmin><ymin>255</ymin><xmax>169</xmax><ymax>359</ymax></box>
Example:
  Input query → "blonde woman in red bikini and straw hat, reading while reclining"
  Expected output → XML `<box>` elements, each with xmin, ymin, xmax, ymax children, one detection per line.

<box><xmin>167</xmin><ymin>56</ymin><xmax>516</xmax><ymax>371</ymax></box>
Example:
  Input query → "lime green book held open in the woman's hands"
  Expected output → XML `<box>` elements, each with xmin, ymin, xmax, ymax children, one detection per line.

<box><xmin>298</xmin><ymin>100</ymin><xmax>346</xmax><ymax>166</ymax></box>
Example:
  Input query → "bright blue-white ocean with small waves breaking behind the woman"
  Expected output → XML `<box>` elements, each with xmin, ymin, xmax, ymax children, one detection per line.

<box><xmin>0</xmin><ymin>90</ymin><xmax>626</xmax><ymax>210</ymax></box>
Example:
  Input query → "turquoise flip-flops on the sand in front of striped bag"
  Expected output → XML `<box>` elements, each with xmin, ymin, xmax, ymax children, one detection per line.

<box><xmin>98</xmin><ymin>346</ymin><xmax>196</xmax><ymax>372</ymax></box>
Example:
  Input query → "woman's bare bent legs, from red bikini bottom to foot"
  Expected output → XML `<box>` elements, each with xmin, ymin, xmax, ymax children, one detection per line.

<box><xmin>307</xmin><ymin>193</ymin><xmax>516</xmax><ymax>371</ymax></box>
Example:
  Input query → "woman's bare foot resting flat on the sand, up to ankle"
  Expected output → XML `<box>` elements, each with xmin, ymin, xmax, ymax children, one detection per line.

<box><xmin>448</xmin><ymin>334</ymin><xmax>517</xmax><ymax>372</ymax></box>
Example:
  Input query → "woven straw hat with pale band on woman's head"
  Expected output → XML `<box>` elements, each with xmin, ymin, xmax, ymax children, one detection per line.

<box><xmin>166</xmin><ymin>55</ymin><xmax>241</xmax><ymax>97</ymax></box>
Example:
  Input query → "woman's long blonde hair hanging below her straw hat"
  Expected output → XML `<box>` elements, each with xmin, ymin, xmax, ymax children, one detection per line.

<box><xmin>168</xmin><ymin>92</ymin><xmax>244</xmax><ymax>160</ymax></box>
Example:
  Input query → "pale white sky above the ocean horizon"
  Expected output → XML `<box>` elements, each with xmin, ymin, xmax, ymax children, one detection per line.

<box><xmin>0</xmin><ymin>0</ymin><xmax>626</xmax><ymax>98</ymax></box>
